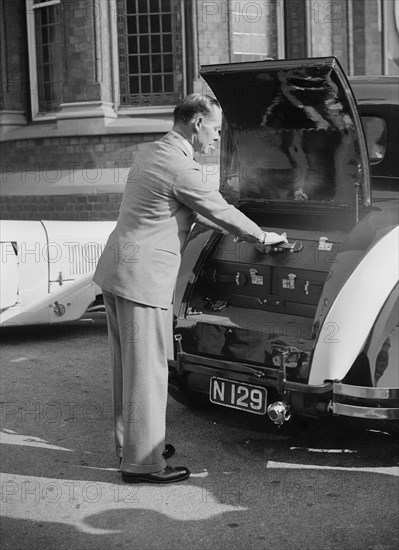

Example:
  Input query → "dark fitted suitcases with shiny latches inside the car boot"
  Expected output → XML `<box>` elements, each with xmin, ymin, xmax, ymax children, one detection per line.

<box><xmin>197</xmin><ymin>231</ymin><xmax>342</xmax><ymax>318</ymax></box>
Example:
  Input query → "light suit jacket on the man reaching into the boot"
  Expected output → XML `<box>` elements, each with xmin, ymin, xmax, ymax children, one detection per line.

<box><xmin>94</xmin><ymin>132</ymin><xmax>262</xmax><ymax>309</ymax></box>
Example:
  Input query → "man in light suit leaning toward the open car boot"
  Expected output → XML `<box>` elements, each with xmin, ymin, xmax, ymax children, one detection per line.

<box><xmin>94</xmin><ymin>94</ymin><xmax>286</xmax><ymax>483</ymax></box>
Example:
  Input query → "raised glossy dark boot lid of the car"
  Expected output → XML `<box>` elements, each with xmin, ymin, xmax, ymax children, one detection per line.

<box><xmin>201</xmin><ymin>57</ymin><xmax>371</xmax><ymax>208</ymax></box>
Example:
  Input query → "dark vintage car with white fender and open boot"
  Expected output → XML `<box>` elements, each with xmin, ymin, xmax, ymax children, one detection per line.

<box><xmin>169</xmin><ymin>57</ymin><xmax>399</xmax><ymax>426</ymax></box>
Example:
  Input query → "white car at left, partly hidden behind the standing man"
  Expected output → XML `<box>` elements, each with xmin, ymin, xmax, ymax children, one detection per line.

<box><xmin>0</xmin><ymin>220</ymin><xmax>115</xmax><ymax>327</ymax></box>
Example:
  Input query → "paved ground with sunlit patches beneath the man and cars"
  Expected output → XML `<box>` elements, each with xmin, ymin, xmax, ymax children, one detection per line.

<box><xmin>1</xmin><ymin>315</ymin><xmax>399</xmax><ymax>550</ymax></box>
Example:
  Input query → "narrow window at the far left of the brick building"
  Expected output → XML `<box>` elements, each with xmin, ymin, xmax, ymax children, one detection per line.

<box><xmin>26</xmin><ymin>0</ymin><xmax>64</xmax><ymax>118</ymax></box>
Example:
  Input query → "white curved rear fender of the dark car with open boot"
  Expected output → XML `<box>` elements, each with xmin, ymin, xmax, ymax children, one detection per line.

<box><xmin>309</xmin><ymin>227</ymin><xmax>399</xmax><ymax>385</ymax></box>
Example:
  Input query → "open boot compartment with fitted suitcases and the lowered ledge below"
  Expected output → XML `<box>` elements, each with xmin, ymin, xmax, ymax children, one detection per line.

<box><xmin>175</xmin><ymin>228</ymin><xmax>344</xmax><ymax>378</ymax></box>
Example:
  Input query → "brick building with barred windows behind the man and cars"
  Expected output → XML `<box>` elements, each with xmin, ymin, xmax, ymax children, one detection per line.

<box><xmin>0</xmin><ymin>0</ymin><xmax>399</xmax><ymax>220</ymax></box>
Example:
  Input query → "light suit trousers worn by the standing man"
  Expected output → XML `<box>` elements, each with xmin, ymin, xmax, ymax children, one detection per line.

<box><xmin>103</xmin><ymin>290</ymin><xmax>168</xmax><ymax>474</ymax></box>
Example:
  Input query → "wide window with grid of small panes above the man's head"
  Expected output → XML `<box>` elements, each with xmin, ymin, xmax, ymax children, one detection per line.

<box><xmin>117</xmin><ymin>0</ymin><xmax>185</xmax><ymax>107</ymax></box>
